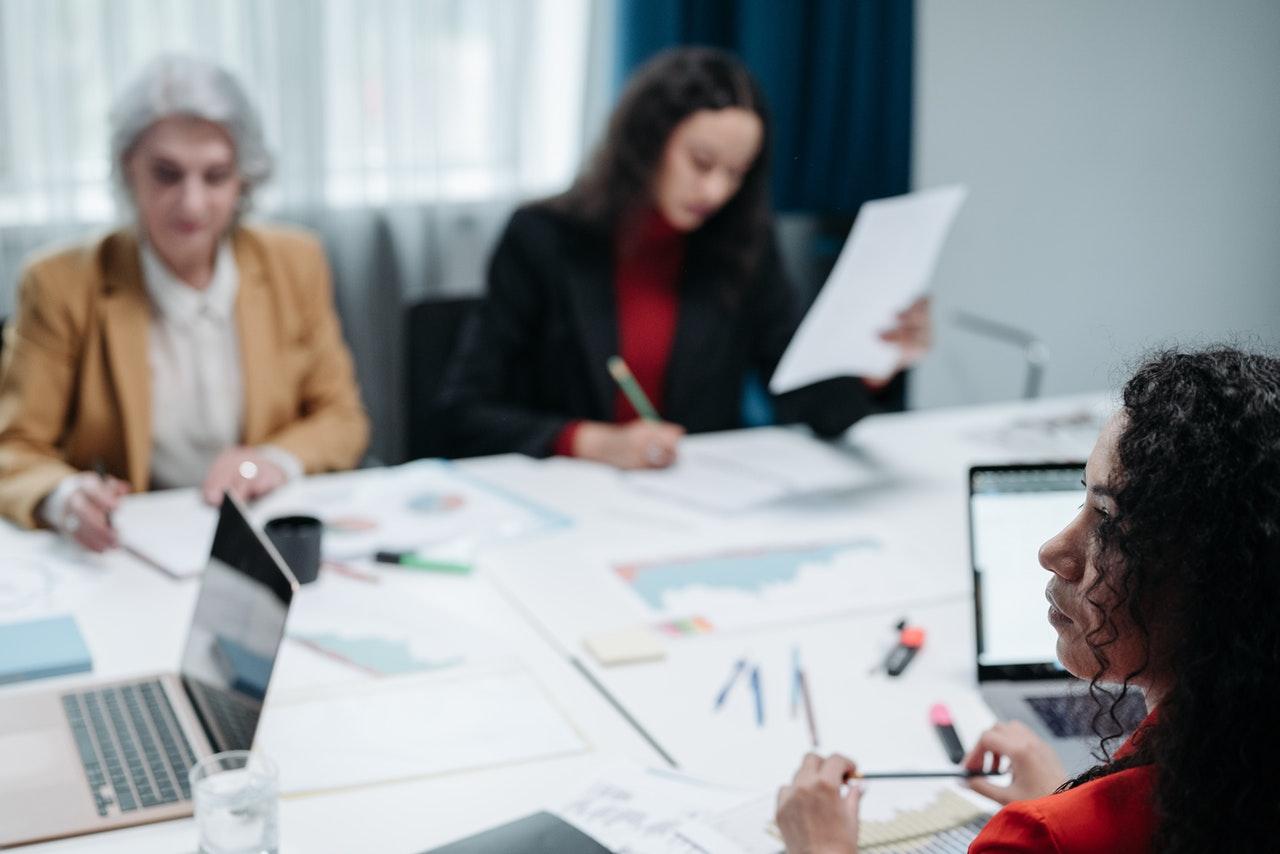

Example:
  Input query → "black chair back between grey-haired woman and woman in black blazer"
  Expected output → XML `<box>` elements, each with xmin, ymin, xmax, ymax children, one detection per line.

<box><xmin>404</xmin><ymin>297</ymin><xmax>480</xmax><ymax>460</ymax></box>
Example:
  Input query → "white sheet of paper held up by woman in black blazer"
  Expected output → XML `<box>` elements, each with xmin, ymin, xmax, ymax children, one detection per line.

<box><xmin>769</xmin><ymin>186</ymin><xmax>968</xmax><ymax>394</ymax></box>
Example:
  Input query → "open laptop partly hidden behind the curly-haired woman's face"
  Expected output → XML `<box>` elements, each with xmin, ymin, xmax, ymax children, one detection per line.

<box><xmin>969</xmin><ymin>462</ymin><xmax>1146</xmax><ymax>775</ymax></box>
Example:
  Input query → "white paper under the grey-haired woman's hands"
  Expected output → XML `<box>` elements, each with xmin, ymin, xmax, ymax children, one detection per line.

<box><xmin>111</xmin><ymin>489</ymin><xmax>218</xmax><ymax>577</ymax></box>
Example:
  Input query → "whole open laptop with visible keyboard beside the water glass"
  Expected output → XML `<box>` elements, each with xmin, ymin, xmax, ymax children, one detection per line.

<box><xmin>0</xmin><ymin>495</ymin><xmax>298</xmax><ymax>848</ymax></box>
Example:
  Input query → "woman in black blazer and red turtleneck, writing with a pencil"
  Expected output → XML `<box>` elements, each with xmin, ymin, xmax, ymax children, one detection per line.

<box><xmin>439</xmin><ymin>49</ymin><xmax>931</xmax><ymax>469</ymax></box>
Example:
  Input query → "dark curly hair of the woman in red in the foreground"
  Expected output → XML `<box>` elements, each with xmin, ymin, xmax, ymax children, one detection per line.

<box><xmin>1064</xmin><ymin>348</ymin><xmax>1280</xmax><ymax>853</ymax></box>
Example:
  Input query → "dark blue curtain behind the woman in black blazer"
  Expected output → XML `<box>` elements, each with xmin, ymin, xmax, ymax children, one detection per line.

<box><xmin>617</xmin><ymin>0</ymin><xmax>915</xmax><ymax>216</ymax></box>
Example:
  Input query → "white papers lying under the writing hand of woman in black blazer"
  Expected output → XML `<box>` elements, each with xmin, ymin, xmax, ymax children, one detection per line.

<box><xmin>625</xmin><ymin>428</ymin><xmax>877</xmax><ymax>513</ymax></box>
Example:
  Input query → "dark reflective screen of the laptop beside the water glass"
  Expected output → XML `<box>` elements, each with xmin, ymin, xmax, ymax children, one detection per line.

<box><xmin>180</xmin><ymin>495</ymin><xmax>297</xmax><ymax>752</ymax></box>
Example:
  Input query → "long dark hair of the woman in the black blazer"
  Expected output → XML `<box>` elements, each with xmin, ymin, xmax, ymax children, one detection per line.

<box><xmin>550</xmin><ymin>47</ymin><xmax>772</xmax><ymax>289</ymax></box>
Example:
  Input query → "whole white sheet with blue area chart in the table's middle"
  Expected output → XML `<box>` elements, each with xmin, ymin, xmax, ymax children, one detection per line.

<box><xmin>486</xmin><ymin>530</ymin><xmax>947</xmax><ymax>648</ymax></box>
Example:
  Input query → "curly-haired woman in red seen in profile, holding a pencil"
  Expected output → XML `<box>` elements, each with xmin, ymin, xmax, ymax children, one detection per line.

<box><xmin>778</xmin><ymin>350</ymin><xmax>1280</xmax><ymax>854</ymax></box>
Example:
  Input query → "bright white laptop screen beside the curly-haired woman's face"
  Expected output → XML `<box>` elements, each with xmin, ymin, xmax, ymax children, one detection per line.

<box><xmin>969</xmin><ymin>463</ymin><xmax>1084</xmax><ymax>680</ymax></box>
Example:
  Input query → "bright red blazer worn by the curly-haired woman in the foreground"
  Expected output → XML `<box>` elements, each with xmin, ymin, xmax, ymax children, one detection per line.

<box><xmin>969</xmin><ymin>716</ymin><xmax>1156</xmax><ymax>854</ymax></box>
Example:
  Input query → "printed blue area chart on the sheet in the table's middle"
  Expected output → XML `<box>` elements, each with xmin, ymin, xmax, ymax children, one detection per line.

<box><xmin>612</xmin><ymin>536</ymin><xmax>920</xmax><ymax>629</ymax></box>
